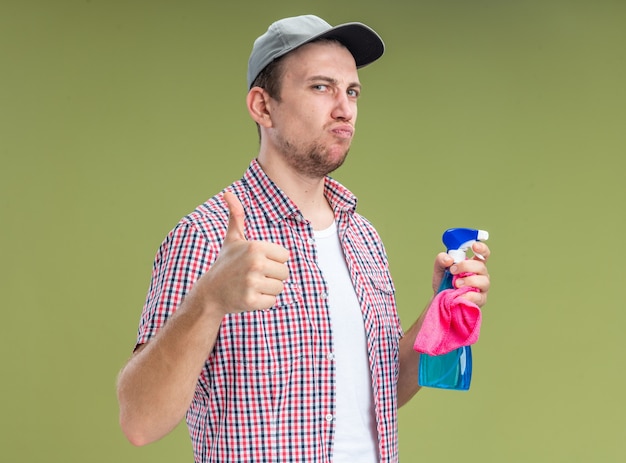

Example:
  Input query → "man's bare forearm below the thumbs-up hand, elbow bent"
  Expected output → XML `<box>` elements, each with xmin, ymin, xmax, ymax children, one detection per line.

<box><xmin>117</xmin><ymin>294</ymin><xmax>221</xmax><ymax>445</ymax></box>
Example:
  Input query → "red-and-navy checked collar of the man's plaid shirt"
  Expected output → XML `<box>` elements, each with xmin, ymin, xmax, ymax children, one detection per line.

<box><xmin>242</xmin><ymin>159</ymin><xmax>357</xmax><ymax>222</ymax></box>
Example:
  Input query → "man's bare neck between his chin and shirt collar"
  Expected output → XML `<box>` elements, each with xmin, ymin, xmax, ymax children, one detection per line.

<box><xmin>258</xmin><ymin>156</ymin><xmax>335</xmax><ymax>230</ymax></box>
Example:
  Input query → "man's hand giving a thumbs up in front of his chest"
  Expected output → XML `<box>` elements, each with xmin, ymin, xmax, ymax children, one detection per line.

<box><xmin>191</xmin><ymin>192</ymin><xmax>289</xmax><ymax>314</ymax></box>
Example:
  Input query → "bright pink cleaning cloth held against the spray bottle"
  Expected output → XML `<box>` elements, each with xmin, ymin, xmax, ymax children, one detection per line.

<box><xmin>413</xmin><ymin>275</ymin><xmax>482</xmax><ymax>355</ymax></box>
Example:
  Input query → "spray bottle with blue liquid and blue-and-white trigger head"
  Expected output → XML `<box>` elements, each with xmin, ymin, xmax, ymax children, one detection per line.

<box><xmin>418</xmin><ymin>228</ymin><xmax>489</xmax><ymax>391</ymax></box>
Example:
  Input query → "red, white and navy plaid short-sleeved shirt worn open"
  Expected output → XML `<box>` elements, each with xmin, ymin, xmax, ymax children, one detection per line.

<box><xmin>137</xmin><ymin>160</ymin><xmax>402</xmax><ymax>463</ymax></box>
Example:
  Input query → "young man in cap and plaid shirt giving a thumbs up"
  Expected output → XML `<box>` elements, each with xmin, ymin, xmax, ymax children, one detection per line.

<box><xmin>118</xmin><ymin>16</ymin><xmax>489</xmax><ymax>463</ymax></box>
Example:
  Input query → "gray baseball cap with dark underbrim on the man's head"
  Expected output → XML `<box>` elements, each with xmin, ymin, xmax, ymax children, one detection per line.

<box><xmin>248</xmin><ymin>15</ymin><xmax>385</xmax><ymax>89</ymax></box>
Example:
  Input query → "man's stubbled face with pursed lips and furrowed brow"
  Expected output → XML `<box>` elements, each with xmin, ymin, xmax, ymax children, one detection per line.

<box><xmin>267</xmin><ymin>42</ymin><xmax>361</xmax><ymax>178</ymax></box>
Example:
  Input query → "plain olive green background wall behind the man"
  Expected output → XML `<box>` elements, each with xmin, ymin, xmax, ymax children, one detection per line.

<box><xmin>0</xmin><ymin>0</ymin><xmax>626</xmax><ymax>463</ymax></box>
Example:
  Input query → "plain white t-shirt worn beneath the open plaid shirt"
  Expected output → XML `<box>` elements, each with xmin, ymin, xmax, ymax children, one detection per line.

<box><xmin>314</xmin><ymin>222</ymin><xmax>378</xmax><ymax>463</ymax></box>
